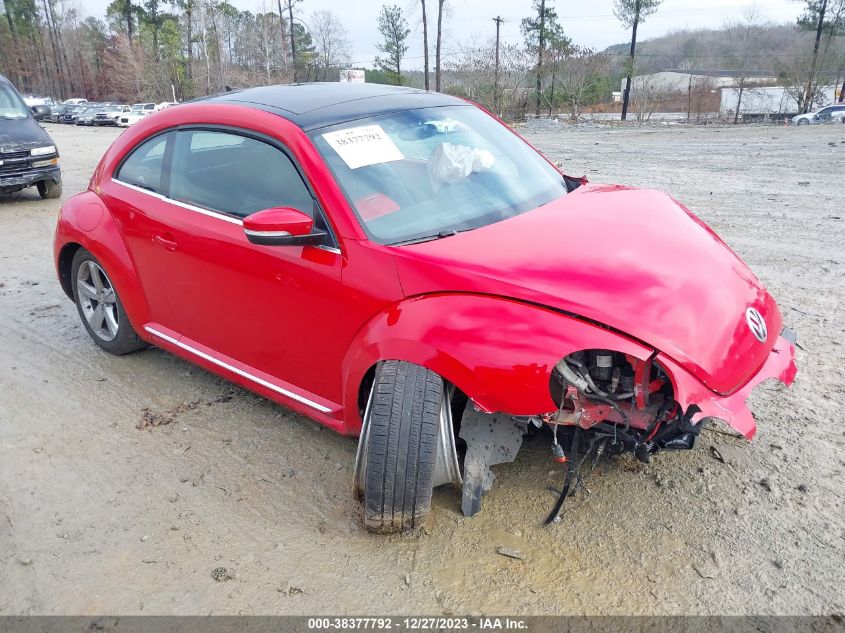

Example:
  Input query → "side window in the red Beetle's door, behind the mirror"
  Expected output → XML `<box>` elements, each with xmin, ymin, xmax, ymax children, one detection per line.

<box><xmin>170</xmin><ymin>130</ymin><xmax>314</xmax><ymax>217</ymax></box>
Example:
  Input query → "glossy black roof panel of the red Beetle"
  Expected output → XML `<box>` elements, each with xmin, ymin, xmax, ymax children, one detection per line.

<box><xmin>201</xmin><ymin>82</ymin><xmax>469</xmax><ymax>130</ymax></box>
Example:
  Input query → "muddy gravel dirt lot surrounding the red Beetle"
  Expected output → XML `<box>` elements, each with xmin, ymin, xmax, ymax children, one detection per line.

<box><xmin>0</xmin><ymin>119</ymin><xmax>845</xmax><ymax>614</ymax></box>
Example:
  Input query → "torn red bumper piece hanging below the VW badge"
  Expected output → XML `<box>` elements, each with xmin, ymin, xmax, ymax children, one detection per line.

<box><xmin>657</xmin><ymin>329</ymin><xmax>798</xmax><ymax>440</ymax></box>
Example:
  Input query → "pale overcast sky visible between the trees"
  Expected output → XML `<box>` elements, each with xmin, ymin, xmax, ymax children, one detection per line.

<box><xmin>82</xmin><ymin>0</ymin><xmax>805</xmax><ymax>68</ymax></box>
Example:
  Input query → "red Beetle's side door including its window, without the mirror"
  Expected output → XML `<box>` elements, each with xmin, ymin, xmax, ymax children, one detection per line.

<box><xmin>147</xmin><ymin>129</ymin><xmax>346</xmax><ymax>402</ymax></box>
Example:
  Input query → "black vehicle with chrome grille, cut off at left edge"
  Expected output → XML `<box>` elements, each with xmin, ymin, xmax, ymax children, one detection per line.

<box><xmin>0</xmin><ymin>75</ymin><xmax>62</xmax><ymax>198</ymax></box>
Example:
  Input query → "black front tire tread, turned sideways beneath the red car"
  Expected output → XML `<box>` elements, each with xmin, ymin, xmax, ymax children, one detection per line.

<box><xmin>362</xmin><ymin>361</ymin><xmax>444</xmax><ymax>534</ymax></box>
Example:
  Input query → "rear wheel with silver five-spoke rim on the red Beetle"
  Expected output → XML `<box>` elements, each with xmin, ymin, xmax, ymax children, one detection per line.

<box><xmin>70</xmin><ymin>248</ymin><xmax>147</xmax><ymax>356</ymax></box>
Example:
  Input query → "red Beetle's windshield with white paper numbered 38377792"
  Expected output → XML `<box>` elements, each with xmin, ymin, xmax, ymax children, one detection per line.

<box><xmin>311</xmin><ymin>106</ymin><xmax>566</xmax><ymax>244</ymax></box>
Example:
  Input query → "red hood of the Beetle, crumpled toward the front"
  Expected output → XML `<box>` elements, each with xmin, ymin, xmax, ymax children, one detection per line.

<box><xmin>393</xmin><ymin>180</ymin><xmax>782</xmax><ymax>394</ymax></box>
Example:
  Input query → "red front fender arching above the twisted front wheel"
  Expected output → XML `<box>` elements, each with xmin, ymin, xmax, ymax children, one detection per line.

<box><xmin>343</xmin><ymin>293</ymin><xmax>653</xmax><ymax>435</ymax></box>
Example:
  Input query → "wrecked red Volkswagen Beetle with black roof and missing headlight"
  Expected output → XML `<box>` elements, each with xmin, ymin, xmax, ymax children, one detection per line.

<box><xmin>55</xmin><ymin>84</ymin><xmax>796</xmax><ymax>532</ymax></box>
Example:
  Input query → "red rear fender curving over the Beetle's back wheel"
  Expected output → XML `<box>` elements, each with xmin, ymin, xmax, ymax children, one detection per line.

<box><xmin>53</xmin><ymin>190</ymin><xmax>150</xmax><ymax>337</ymax></box>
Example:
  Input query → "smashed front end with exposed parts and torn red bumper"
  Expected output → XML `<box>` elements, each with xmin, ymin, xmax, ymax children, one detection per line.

<box><xmin>460</xmin><ymin>328</ymin><xmax>797</xmax><ymax>524</ymax></box>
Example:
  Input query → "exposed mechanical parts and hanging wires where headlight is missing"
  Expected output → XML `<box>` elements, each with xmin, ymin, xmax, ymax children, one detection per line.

<box><xmin>454</xmin><ymin>349</ymin><xmax>701</xmax><ymax>524</ymax></box>
